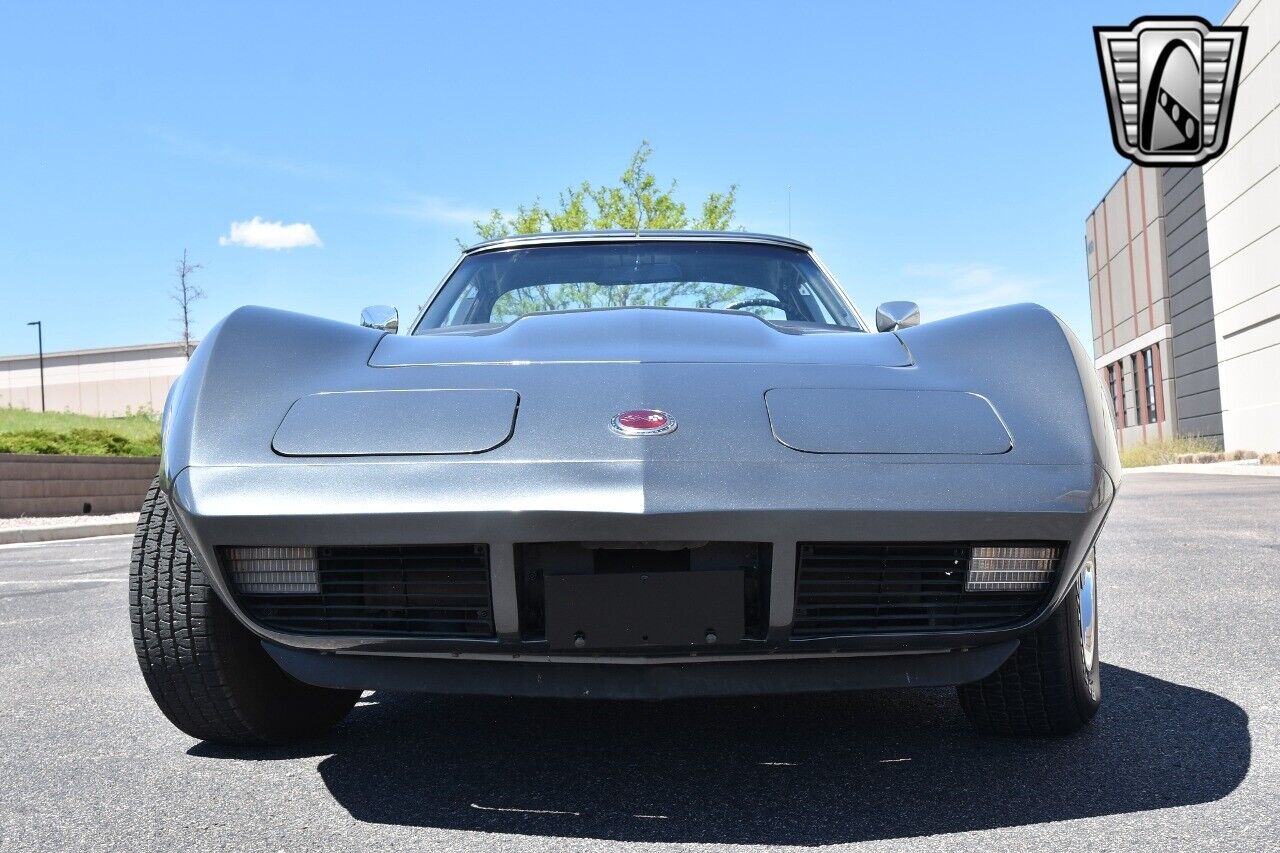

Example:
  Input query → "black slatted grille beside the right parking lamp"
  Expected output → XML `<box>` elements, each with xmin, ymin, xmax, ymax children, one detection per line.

<box><xmin>791</xmin><ymin>542</ymin><xmax>1061</xmax><ymax>638</ymax></box>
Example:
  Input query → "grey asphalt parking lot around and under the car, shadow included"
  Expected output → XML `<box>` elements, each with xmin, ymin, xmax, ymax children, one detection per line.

<box><xmin>0</xmin><ymin>474</ymin><xmax>1280</xmax><ymax>850</ymax></box>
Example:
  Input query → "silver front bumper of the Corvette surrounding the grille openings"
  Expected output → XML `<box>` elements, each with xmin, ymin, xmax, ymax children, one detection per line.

<box><xmin>168</xmin><ymin>455</ymin><xmax>1115</xmax><ymax>666</ymax></box>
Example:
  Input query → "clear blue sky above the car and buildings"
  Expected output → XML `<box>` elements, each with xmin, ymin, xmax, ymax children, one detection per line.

<box><xmin>0</xmin><ymin>0</ymin><xmax>1230</xmax><ymax>353</ymax></box>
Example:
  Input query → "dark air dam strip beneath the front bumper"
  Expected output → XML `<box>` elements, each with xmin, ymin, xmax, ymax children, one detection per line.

<box><xmin>262</xmin><ymin>640</ymin><xmax>1018</xmax><ymax>699</ymax></box>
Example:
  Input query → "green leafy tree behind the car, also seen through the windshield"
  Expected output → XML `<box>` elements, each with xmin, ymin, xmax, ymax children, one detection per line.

<box><xmin>474</xmin><ymin>141</ymin><xmax>742</xmax><ymax>319</ymax></box>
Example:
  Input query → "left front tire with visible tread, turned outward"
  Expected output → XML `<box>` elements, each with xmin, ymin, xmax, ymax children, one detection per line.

<box><xmin>129</xmin><ymin>478</ymin><xmax>360</xmax><ymax>745</ymax></box>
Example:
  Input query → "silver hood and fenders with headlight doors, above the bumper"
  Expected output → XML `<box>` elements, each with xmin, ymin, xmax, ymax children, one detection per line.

<box><xmin>161</xmin><ymin>300</ymin><xmax>1114</xmax><ymax>473</ymax></box>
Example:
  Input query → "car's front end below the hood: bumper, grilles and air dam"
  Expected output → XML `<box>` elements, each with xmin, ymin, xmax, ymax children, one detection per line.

<box><xmin>172</xmin><ymin>450</ymin><xmax>1110</xmax><ymax>695</ymax></box>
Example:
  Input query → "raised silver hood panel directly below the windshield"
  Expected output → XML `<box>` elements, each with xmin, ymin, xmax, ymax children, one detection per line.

<box><xmin>369</xmin><ymin>307</ymin><xmax>911</xmax><ymax>368</ymax></box>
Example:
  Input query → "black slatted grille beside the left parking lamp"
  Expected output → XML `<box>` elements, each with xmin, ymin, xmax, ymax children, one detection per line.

<box><xmin>223</xmin><ymin>544</ymin><xmax>494</xmax><ymax>638</ymax></box>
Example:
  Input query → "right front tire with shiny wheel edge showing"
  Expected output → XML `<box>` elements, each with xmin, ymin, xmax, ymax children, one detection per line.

<box><xmin>956</xmin><ymin>551</ymin><xmax>1102</xmax><ymax>735</ymax></box>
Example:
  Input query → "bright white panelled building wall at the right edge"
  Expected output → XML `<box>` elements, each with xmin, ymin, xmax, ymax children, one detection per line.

<box><xmin>1204</xmin><ymin>0</ymin><xmax>1280</xmax><ymax>451</ymax></box>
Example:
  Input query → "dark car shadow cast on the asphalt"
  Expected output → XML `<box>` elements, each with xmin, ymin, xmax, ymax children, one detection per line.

<box><xmin>192</xmin><ymin>666</ymin><xmax>1251</xmax><ymax>845</ymax></box>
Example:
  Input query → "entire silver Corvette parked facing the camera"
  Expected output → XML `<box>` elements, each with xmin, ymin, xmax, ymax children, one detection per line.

<box><xmin>131</xmin><ymin>232</ymin><xmax>1119</xmax><ymax>743</ymax></box>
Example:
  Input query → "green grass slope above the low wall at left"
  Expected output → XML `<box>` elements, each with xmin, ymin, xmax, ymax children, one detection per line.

<box><xmin>0</xmin><ymin>409</ymin><xmax>160</xmax><ymax>456</ymax></box>
